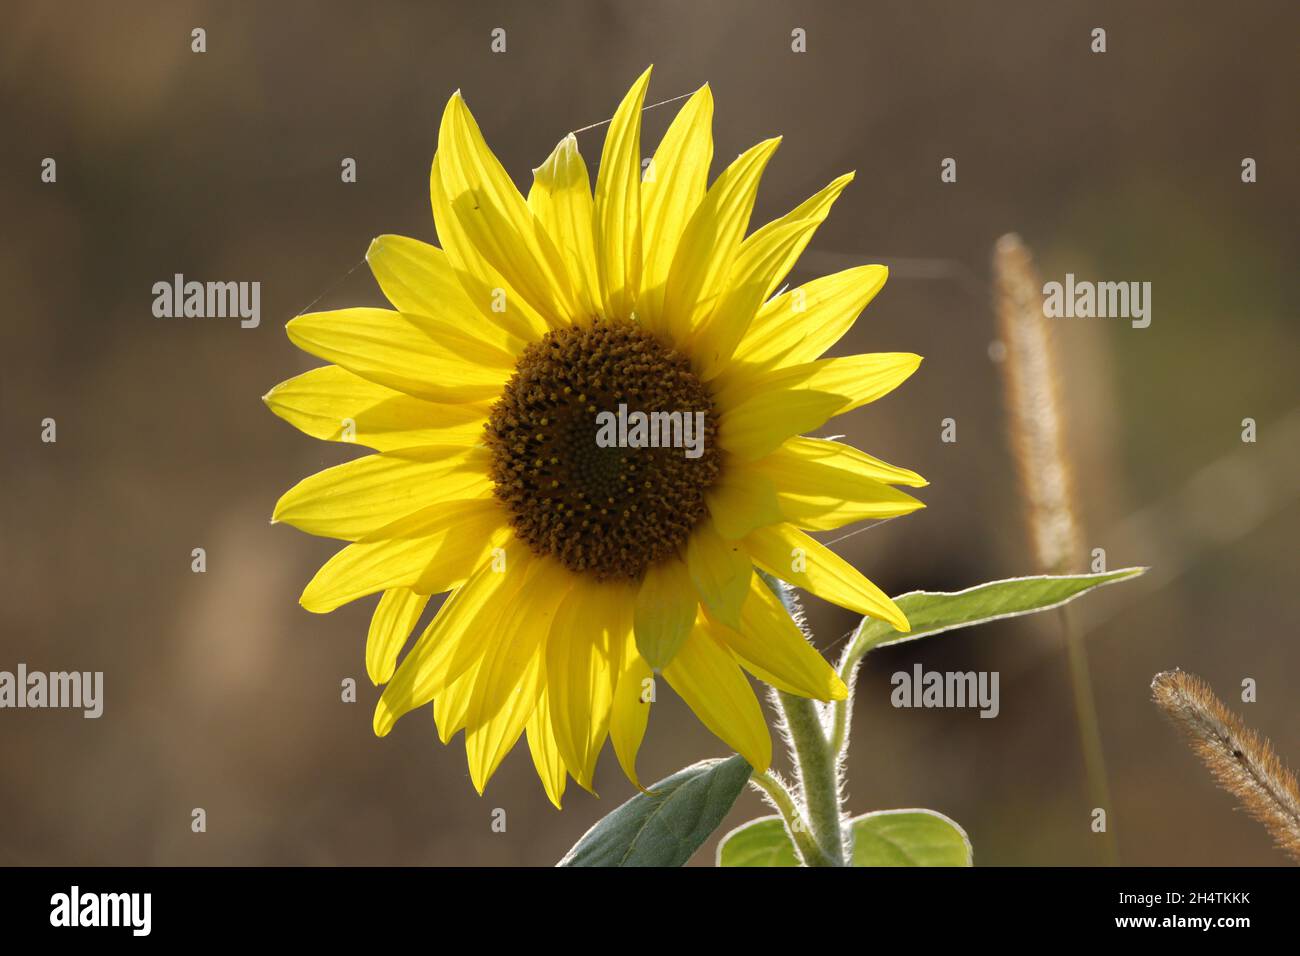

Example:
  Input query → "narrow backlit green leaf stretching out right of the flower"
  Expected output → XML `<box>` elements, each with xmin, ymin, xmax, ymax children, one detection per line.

<box><xmin>846</xmin><ymin>567</ymin><xmax>1147</xmax><ymax>661</ymax></box>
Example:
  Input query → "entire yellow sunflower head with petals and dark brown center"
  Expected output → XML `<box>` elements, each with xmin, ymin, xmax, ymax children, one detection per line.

<box><xmin>265</xmin><ymin>70</ymin><xmax>926</xmax><ymax>806</ymax></box>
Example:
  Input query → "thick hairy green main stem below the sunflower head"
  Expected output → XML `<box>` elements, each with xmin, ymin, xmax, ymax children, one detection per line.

<box><xmin>759</xmin><ymin>572</ymin><xmax>848</xmax><ymax>866</ymax></box>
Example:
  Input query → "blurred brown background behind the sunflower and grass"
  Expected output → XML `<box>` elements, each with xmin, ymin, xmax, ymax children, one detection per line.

<box><xmin>0</xmin><ymin>0</ymin><xmax>1300</xmax><ymax>865</ymax></box>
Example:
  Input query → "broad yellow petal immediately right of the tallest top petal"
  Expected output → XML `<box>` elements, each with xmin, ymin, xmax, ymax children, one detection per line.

<box><xmin>637</xmin><ymin>83</ymin><xmax>714</xmax><ymax>334</ymax></box>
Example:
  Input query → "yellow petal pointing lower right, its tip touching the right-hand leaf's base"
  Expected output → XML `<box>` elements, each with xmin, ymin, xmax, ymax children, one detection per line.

<box><xmin>745</xmin><ymin>524</ymin><xmax>911</xmax><ymax>631</ymax></box>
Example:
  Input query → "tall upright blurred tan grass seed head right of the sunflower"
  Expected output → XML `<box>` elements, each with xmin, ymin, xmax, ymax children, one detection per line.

<box><xmin>993</xmin><ymin>233</ymin><xmax>1080</xmax><ymax>571</ymax></box>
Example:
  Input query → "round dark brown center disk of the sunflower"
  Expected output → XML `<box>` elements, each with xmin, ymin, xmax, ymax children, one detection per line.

<box><xmin>486</xmin><ymin>321</ymin><xmax>720</xmax><ymax>579</ymax></box>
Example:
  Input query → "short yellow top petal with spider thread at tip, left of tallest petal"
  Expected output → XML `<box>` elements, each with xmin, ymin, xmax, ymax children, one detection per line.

<box><xmin>528</xmin><ymin>133</ymin><xmax>601</xmax><ymax>319</ymax></box>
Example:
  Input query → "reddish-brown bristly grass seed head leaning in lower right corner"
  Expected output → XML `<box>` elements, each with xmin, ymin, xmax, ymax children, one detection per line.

<box><xmin>1151</xmin><ymin>670</ymin><xmax>1300</xmax><ymax>862</ymax></box>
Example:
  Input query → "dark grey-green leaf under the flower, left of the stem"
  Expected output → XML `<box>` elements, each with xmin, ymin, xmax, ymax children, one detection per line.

<box><xmin>558</xmin><ymin>754</ymin><xmax>751</xmax><ymax>866</ymax></box>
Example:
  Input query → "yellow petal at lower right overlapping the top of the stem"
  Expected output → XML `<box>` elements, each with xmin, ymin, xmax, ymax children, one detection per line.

<box><xmin>705</xmin><ymin>575</ymin><xmax>849</xmax><ymax>700</ymax></box>
